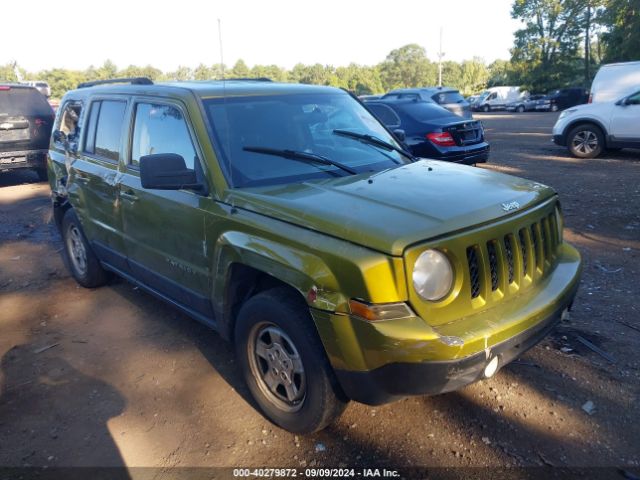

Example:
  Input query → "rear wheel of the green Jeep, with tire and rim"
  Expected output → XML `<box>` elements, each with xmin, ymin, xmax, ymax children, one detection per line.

<box><xmin>62</xmin><ymin>208</ymin><xmax>109</xmax><ymax>288</ymax></box>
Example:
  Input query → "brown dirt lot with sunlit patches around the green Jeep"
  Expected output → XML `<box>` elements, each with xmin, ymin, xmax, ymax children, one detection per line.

<box><xmin>0</xmin><ymin>113</ymin><xmax>640</xmax><ymax>478</ymax></box>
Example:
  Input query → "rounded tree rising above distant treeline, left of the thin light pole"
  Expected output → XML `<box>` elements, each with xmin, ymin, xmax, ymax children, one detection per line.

<box><xmin>379</xmin><ymin>43</ymin><xmax>437</xmax><ymax>90</ymax></box>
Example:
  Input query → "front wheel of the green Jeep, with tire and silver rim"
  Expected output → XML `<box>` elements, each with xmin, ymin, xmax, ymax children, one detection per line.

<box><xmin>235</xmin><ymin>287</ymin><xmax>348</xmax><ymax>434</ymax></box>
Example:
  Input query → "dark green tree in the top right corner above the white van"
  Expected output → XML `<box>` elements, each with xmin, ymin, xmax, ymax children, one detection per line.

<box><xmin>598</xmin><ymin>0</ymin><xmax>640</xmax><ymax>63</ymax></box>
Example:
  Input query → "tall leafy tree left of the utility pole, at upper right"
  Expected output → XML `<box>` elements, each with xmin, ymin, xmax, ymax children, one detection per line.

<box><xmin>511</xmin><ymin>0</ymin><xmax>589</xmax><ymax>91</ymax></box>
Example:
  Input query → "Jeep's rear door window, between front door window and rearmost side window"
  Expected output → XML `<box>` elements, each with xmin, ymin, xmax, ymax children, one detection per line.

<box><xmin>85</xmin><ymin>100</ymin><xmax>127</xmax><ymax>162</ymax></box>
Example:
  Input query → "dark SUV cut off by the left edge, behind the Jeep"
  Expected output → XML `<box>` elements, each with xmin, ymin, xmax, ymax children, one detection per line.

<box><xmin>0</xmin><ymin>84</ymin><xmax>54</xmax><ymax>180</ymax></box>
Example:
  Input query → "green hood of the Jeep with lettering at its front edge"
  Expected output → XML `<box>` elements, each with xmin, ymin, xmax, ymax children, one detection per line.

<box><xmin>225</xmin><ymin>160</ymin><xmax>554</xmax><ymax>256</ymax></box>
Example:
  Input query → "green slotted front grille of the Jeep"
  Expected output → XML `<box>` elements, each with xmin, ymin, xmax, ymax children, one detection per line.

<box><xmin>467</xmin><ymin>213</ymin><xmax>560</xmax><ymax>299</ymax></box>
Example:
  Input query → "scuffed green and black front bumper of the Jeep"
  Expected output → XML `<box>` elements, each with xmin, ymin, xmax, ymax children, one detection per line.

<box><xmin>312</xmin><ymin>243</ymin><xmax>581</xmax><ymax>405</ymax></box>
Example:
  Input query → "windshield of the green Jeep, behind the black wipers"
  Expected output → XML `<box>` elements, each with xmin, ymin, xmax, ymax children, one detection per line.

<box><xmin>204</xmin><ymin>92</ymin><xmax>410</xmax><ymax>188</ymax></box>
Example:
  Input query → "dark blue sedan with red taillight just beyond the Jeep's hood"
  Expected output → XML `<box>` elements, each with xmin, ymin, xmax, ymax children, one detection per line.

<box><xmin>366</xmin><ymin>98</ymin><xmax>489</xmax><ymax>165</ymax></box>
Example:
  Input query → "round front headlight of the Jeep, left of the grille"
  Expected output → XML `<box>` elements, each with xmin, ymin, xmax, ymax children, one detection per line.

<box><xmin>413</xmin><ymin>250</ymin><xmax>453</xmax><ymax>302</ymax></box>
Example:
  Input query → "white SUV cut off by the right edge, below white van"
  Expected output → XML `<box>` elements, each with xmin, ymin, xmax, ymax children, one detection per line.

<box><xmin>553</xmin><ymin>89</ymin><xmax>640</xmax><ymax>158</ymax></box>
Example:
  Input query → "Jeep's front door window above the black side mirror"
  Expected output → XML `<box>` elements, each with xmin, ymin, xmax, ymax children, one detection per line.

<box><xmin>131</xmin><ymin>103</ymin><xmax>196</xmax><ymax>169</ymax></box>
